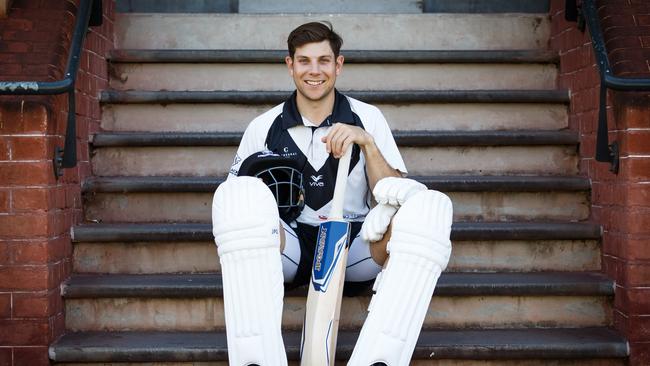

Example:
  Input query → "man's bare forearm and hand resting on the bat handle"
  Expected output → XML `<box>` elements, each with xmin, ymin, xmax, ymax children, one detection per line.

<box><xmin>322</xmin><ymin>123</ymin><xmax>402</xmax><ymax>191</ymax></box>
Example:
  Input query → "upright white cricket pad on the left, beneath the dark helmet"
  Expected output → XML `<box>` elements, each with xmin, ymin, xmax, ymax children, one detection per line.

<box><xmin>212</xmin><ymin>177</ymin><xmax>287</xmax><ymax>366</ymax></box>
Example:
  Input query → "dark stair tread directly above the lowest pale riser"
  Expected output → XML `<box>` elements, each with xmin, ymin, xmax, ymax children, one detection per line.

<box><xmin>63</xmin><ymin>272</ymin><xmax>614</xmax><ymax>299</ymax></box>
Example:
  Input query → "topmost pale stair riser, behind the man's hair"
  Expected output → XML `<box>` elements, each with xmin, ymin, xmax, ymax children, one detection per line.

<box><xmin>115</xmin><ymin>14</ymin><xmax>550</xmax><ymax>50</ymax></box>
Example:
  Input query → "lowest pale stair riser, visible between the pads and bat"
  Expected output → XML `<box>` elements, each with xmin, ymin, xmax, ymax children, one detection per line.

<box><xmin>65</xmin><ymin>296</ymin><xmax>611</xmax><ymax>331</ymax></box>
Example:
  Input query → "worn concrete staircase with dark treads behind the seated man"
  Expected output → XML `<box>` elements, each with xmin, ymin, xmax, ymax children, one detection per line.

<box><xmin>50</xmin><ymin>6</ymin><xmax>628</xmax><ymax>366</ymax></box>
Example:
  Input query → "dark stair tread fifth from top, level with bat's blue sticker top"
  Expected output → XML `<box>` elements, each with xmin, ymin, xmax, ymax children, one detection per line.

<box><xmin>72</xmin><ymin>222</ymin><xmax>602</xmax><ymax>242</ymax></box>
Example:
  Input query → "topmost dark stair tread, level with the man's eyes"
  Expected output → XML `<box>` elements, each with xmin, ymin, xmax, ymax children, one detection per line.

<box><xmin>108</xmin><ymin>49</ymin><xmax>559</xmax><ymax>64</ymax></box>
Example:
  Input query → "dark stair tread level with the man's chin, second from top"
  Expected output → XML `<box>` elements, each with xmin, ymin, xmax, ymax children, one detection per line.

<box><xmin>100</xmin><ymin>90</ymin><xmax>569</xmax><ymax>104</ymax></box>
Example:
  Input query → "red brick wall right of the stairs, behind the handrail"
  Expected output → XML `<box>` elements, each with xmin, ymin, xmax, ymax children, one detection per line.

<box><xmin>550</xmin><ymin>0</ymin><xmax>650</xmax><ymax>365</ymax></box>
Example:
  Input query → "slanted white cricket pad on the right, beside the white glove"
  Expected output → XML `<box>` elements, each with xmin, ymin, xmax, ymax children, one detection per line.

<box><xmin>348</xmin><ymin>191</ymin><xmax>453</xmax><ymax>366</ymax></box>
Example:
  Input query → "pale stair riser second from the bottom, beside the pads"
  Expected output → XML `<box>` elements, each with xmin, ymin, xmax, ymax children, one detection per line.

<box><xmin>73</xmin><ymin>240</ymin><xmax>600</xmax><ymax>274</ymax></box>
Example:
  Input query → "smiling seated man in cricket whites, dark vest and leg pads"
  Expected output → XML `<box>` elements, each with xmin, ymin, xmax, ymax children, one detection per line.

<box><xmin>213</xmin><ymin>22</ymin><xmax>451</xmax><ymax>366</ymax></box>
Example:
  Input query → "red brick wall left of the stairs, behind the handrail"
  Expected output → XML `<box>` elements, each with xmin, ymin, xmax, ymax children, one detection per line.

<box><xmin>0</xmin><ymin>0</ymin><xmax>114</xmax><ymax>366</ymax></box>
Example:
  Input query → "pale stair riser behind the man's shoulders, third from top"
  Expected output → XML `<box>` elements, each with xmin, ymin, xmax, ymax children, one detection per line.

<box><xmin>102</xmin><ymin>103</ymin><xmax>568</xmax><ymax>132</ymax></box>
